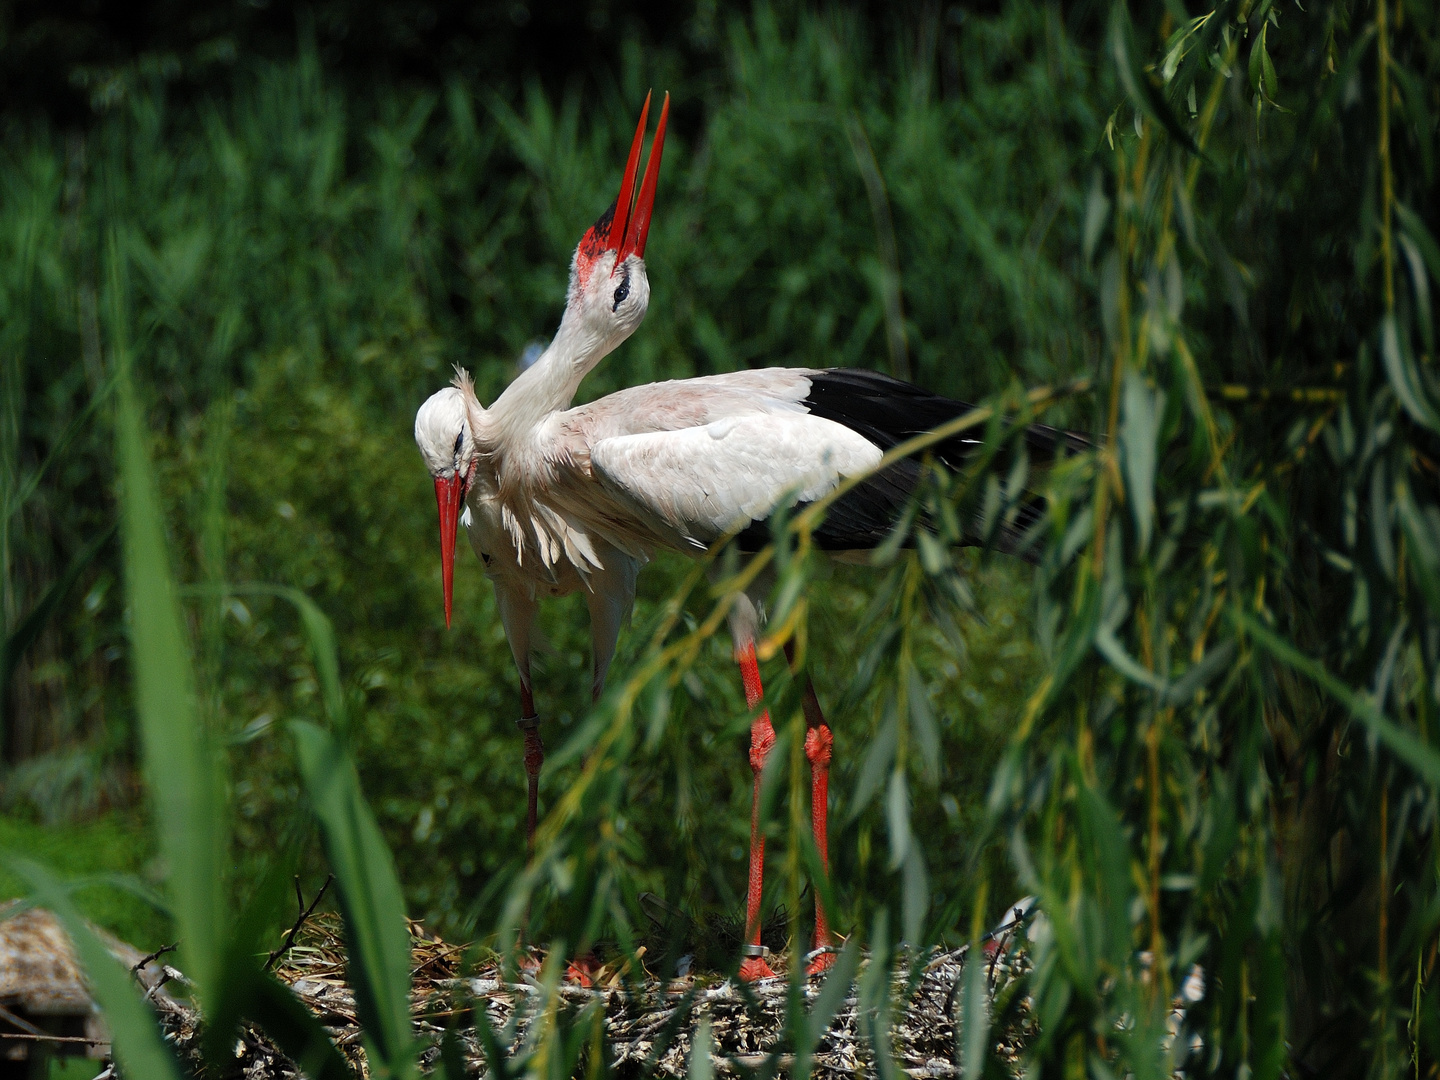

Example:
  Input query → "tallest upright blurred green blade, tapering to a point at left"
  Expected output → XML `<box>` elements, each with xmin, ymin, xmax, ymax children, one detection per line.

<box><xmin>111</xmin><ymin>244</ymin><xmax>228</xmax><ymax>999</ymax></box>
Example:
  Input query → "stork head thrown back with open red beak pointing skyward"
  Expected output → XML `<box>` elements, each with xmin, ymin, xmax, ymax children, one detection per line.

<box><xmin>566</xmin><ymin>94</ymin><xmax>670</xmax><ymax>347</ymax></box>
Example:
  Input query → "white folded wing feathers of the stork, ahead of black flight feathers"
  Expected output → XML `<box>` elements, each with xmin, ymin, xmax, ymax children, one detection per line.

<box><xmin>590</xmin><ymin>412</ymin><xmax>881</xmax><ymax>547</ymax></box>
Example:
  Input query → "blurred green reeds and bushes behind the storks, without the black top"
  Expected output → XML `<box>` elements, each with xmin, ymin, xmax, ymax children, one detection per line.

<box><xmin>0</xmin><ymin>10</ymin><xmax>1099</xmax><ymax>933</ymax></box>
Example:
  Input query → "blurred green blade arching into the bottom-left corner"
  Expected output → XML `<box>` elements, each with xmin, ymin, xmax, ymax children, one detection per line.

<box><xmin>0</xmin><ymin>852</ymin><xmax>180</xmax><ymax>1080</ymax></box>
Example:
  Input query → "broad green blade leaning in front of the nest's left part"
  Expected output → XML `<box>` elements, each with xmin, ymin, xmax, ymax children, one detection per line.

<box><xmin>291</xmin><ymin>720</ymin><xmax>415</xmax><ymax>1077</ymax></box>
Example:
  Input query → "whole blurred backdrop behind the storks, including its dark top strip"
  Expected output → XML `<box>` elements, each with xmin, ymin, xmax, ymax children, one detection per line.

<box><xmin>0</xmin><ymin>0</ymin><xmax>1100</xmax><ymax>948</ymax></box>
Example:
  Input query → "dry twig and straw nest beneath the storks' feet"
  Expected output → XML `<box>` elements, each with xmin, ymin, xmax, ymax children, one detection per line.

<box><xmin>143</xmin><ymin>916</ymin><xmax>1035</xmax><ymax>1080</ymax></box>
